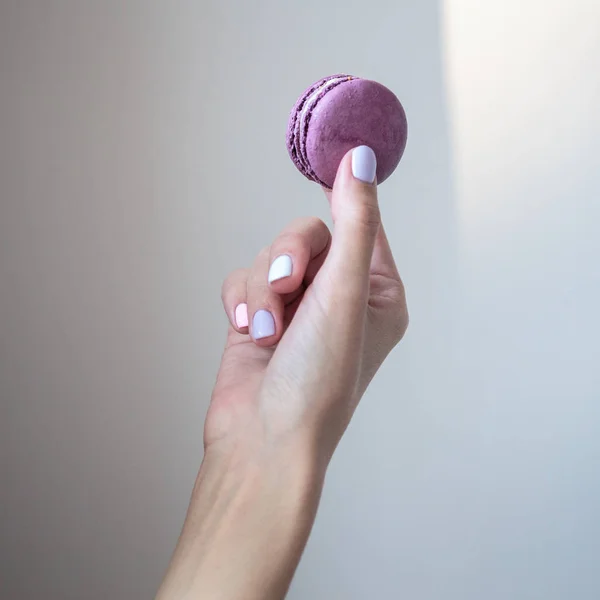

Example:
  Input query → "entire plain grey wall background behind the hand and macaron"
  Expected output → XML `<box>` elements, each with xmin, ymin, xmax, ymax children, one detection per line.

<box><xmin>0</xmin><ymin>0</ymin><xmax>600</xmax><ymax>600</ymax></box>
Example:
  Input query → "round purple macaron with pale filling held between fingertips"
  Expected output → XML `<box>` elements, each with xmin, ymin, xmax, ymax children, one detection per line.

<box><xmin>287</xmin><ymin>75</ymin><xmax>408</xmax><ymax>189</ymax></box>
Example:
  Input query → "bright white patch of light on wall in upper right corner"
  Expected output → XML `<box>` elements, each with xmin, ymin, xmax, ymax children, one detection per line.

<box><xmin>443</xmin><ymin>0</ymin><xmax>600</xmax><ymax>244</ymax></box>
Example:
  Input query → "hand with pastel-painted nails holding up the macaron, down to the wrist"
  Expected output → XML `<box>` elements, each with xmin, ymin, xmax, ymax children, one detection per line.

<box><xmin>205</xmin><ymin>147</ymin><xmax>408</xmax><ymax>461</ymax></box>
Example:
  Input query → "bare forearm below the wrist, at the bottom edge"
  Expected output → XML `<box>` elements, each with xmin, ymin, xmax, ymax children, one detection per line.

<box><xmin>157</xmin><ymin>438</ymin><xmax>324</xmax><ymax>600</ymax></box>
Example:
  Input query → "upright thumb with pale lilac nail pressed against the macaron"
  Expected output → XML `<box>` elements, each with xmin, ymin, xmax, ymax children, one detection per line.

<box><xmin>322</xmin><ymin>146</ymin><xmax>381</xmax><ymax>303</ymax></box>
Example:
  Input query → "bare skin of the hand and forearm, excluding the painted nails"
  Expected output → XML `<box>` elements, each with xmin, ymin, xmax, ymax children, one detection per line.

<box><xmin>157</xmin><ymin>146</ymin><xmax>408</xmax><ymax>600</ymax></box>
